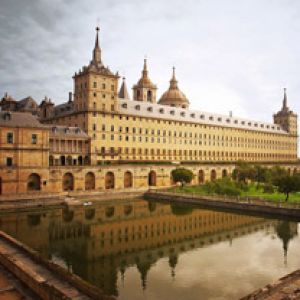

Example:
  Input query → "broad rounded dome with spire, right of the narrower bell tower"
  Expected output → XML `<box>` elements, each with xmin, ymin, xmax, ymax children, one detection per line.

<box><xmin>158</xmin><ymin>68</ymin><xmax>190</xmax><ymax>108</ymax></box>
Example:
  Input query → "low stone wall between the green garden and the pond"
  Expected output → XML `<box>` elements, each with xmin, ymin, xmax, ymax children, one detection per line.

<box><xmin>149</xmin><ymin>189</ymin><xmax>300</xmax><ymax>209</ymax></box>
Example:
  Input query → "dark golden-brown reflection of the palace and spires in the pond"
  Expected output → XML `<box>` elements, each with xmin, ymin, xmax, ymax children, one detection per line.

<box><xmin>0</xmin><ymin>200</ymin><xmax>297</xmax><ymax>295</ymax></box>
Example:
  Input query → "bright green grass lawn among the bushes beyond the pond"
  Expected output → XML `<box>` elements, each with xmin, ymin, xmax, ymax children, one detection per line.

<box><xmin>171</xmin><ymin>184</ymin><xmax>300</xmax><ymax>203</ymax></box>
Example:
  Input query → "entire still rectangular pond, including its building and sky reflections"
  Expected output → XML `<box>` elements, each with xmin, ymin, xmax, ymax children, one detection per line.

<box><xmin>0</xmin><ymin>199</ymin><xmax>300</xmax><ymax>300</ymax></box>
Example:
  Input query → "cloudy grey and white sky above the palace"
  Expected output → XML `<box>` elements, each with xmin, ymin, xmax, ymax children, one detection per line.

<box><xmin>0</xmin><ymin>0</ymin><xmax>300</xmax><ymax>121</ymax></box>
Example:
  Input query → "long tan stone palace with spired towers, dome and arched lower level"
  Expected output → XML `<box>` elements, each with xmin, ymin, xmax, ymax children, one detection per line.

<box><xmin>0</xmin><ymin>28</ymin><xmax>300</xmax><ymax>195</ymax></box>
